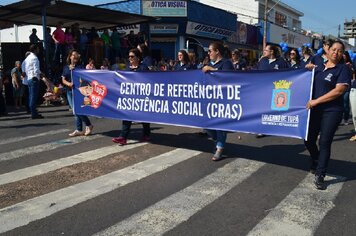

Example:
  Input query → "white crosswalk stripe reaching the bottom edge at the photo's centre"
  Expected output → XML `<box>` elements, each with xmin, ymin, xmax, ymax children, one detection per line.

<box><xmin>95</xmin><ymin>159</ymin><xmax>265</xmax><ymax>236</ymax></box>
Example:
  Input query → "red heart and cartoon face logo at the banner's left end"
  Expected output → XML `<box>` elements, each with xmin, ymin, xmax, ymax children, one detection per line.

<box><xmin>79</xmin><ymin>78</ymin><xmax>107</xmax><ymax>109</ymax></box>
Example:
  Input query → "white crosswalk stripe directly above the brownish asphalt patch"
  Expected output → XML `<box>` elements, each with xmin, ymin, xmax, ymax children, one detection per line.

<box><xmin>0</xmin><ymin>141</ymin><xmax>147</xmax><ymax>185</ymax></box>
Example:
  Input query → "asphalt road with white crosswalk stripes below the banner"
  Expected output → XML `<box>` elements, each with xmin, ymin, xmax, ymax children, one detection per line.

<box><xmin>0</xmin><ymin>106</ymin><xmax>356</xmax><ymax>236</ymax></box>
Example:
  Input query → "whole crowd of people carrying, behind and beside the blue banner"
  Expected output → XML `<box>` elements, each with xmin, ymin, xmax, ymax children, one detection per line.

<box><xmin>0</xmin><ymin>34</ymin><xmax>356</xmax><ymax>189</ymax></box>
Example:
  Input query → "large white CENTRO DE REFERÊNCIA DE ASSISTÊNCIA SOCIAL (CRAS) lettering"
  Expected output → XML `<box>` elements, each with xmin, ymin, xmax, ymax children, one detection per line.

<box><xmin>116</xmin><ymin>82</ymin><xmax>242</xmax><ymax>120</ymax></box>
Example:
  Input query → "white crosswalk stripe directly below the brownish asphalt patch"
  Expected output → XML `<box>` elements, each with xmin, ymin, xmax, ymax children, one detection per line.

<box><xmin>0</xmin><ymin>149</ymin><xmax>201</xmax><ymax>233</ymax></box>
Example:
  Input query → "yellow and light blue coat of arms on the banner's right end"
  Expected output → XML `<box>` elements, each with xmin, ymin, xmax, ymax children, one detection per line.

<box><xmin>271</xmin><ymin>80</ymin><xmax>292</xmax><ymax>111</ymax></box>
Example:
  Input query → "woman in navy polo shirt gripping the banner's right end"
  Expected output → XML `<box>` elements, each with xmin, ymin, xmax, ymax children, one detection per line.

<box><xmin>304</xmin><ymin>41</ymin><xmax>352</xmax><ymax>190</ymax></box>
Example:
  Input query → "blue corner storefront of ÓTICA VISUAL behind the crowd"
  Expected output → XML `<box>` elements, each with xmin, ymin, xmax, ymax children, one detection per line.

<box><xmin>99</xmin><ymin>0</ymin><xmax>237</xmax><ymax>60</ymax></box>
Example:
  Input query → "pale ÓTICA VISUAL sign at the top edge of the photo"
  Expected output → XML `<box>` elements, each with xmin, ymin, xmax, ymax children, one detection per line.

<box><xmin>142</xmin><ymin>0</ymin><xmax>187</xmax><ymax>17</ymax></box>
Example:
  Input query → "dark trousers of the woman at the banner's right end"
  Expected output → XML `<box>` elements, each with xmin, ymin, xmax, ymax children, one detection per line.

<box><xmin>304</xmin><ymin>108</ymin><xmax>342</xmax><ymax>176</ymax></box>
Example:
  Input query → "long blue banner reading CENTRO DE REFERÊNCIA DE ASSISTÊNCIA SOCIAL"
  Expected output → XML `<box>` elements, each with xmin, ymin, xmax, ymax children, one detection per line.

<box><xmin>73</xmin><ymin>70</ymin><xmax>312</xmax><ymax>139</ymax></box>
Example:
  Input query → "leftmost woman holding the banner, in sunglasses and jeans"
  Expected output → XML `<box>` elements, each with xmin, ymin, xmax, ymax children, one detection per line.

<box><xmin>62</xmin><ymin>49</ymin><xmax>93</xmax><ymax>137</ymax></box>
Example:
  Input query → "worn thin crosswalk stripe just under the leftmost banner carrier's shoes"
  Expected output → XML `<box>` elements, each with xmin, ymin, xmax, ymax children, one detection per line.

<box><xmin>0</xmin><ymin>134</ymin><xmax>105</xmax><ymax>161</ymax></box>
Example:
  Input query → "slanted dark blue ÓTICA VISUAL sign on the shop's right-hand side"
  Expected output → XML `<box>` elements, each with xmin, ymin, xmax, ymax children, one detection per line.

<box><xmin>187</xmin><ymin>21</ymin><xmax>234</xmax><ymax>40</ymax></box>
